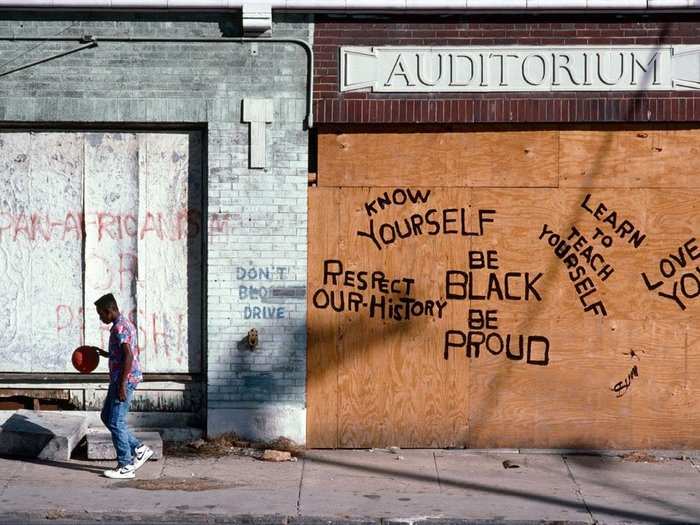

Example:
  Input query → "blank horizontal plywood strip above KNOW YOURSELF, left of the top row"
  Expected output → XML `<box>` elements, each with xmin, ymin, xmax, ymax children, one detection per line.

<box><xmin>318</xmin><ymin>131</ymin><xmax>558</xmax><ymax>187</ymax></box>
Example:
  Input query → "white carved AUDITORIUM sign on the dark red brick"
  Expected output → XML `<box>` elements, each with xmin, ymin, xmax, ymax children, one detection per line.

<box><xmin>340</xmin><ymin>46</ymin><xmax>700</xmax><ymax>93</ymax></box>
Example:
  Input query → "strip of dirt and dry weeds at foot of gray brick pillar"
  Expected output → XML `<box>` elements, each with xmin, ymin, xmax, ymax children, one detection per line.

<box><xmin>163</xmin><ymin>434</ymin><xmax>304</xmax><ymax>459</ymax></box>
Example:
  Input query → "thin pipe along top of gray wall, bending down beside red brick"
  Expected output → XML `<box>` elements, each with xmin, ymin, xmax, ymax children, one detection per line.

<box><xmin>0</xmin><ymin>35</ymin><xmax>314</xmax><ymax>129</ymax></box>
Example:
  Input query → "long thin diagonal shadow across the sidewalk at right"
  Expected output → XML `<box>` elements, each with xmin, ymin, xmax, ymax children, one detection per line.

<box><xmin>304</xmin><ymin>453</ymin><xmax>700</xmax><ymax>523</ymax></box>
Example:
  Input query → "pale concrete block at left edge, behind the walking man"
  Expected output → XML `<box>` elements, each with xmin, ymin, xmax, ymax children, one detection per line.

<box><xmin>0</xmin><ymin>410</ymin><xmax>87</xmax><ymax>461</ymax></box>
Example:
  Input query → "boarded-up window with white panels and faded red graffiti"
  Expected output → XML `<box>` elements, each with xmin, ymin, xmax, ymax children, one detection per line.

<box><xmin>0</xmin><ymin>132</ymin><xmax>203</xmax><ymax>373</ymax></box>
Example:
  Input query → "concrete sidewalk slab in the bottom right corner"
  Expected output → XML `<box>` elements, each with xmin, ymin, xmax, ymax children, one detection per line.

<box><xmin>565</xmin><ymin>456</ymin><xmax>700</xmax><ymax>523</ymax></box>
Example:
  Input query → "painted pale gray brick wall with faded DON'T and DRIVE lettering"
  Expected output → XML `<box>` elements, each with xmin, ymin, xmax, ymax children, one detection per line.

<box><xmin>0</xmin><ymin>12</ymin><xmax>312</xmax><ymax>441</ymax></box>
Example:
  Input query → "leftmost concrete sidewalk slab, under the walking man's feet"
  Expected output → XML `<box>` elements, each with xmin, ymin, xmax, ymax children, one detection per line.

<box><xmin>0</xmin><ymin>457</ymin><xmax>301</xmax><ymax>522</ymax></box>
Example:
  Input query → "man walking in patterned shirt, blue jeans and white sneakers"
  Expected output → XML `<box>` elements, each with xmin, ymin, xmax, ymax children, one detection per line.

<box><xmin>95</xmin><ymin>294</ymin><xmax>153</xmax><ymax>479</ymax></box>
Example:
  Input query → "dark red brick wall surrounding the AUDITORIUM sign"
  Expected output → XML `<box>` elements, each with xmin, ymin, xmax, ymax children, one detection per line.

<box><xmin>314</xmin><ymin>14</ymin><xmax>700</xmax><ymax>125</ymax></box>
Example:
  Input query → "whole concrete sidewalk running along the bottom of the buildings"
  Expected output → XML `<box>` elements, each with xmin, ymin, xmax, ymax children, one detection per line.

<box><xmin>0</xmin><ymin>450</ymin><xmax>700</xmax><ymax>525</ymax></box>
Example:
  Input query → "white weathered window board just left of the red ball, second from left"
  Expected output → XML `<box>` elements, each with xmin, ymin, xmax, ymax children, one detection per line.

<box><xmin>30</xmin><ymin>133</ymin><xmax>84</xmax><ymax>372</ymax></box>
